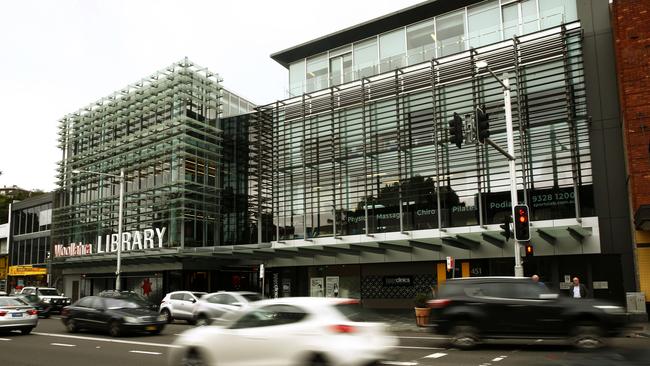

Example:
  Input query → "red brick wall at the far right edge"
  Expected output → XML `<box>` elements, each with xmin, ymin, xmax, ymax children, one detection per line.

<box><xmin>612</xmin><ymin>0</ymin><xmax>650</xmax><ymax>213</ymax></box>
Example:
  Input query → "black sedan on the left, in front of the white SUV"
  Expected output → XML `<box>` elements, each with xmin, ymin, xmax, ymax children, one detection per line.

<box><xmin>61</xmin><ymin>296</ymin><xmax>166</xmax><ymax>337</ymax></box>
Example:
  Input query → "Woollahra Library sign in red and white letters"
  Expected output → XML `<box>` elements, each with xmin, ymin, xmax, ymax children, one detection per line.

<box><xmin>54</xmin><ymin>227</ymin><xmax>167</xmax><ymax>257</ymax></box>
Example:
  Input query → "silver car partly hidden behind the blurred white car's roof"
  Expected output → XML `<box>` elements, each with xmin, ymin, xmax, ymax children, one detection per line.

<box><xmin>193</xmin><ymin>291</ymin><xmax>262</xmax><ymax>325</ymax></box>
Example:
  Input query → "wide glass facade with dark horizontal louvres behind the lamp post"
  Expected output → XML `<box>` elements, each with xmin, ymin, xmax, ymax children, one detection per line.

<box><xmin>263</xmin><ymin>23</ymin><xmax>594</xmax><ymax>240</ymax></box>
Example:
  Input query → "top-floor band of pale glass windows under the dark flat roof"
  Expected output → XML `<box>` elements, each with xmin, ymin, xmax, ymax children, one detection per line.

<box><xmin>289</xmin><ymin>0</ymin><xmax>577</xmax><ymax>97</ymax></box>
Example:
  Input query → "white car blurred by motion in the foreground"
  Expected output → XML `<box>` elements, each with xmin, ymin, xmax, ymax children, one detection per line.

<box><xmin>168</xmin><ymin>297</ymin><xmax>398</xmax><ymax>366</ymax></box>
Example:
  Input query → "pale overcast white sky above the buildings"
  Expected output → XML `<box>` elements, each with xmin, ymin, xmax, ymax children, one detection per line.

<box><xmin>0</xmin><ymin>0</ymin><xmax>421</xmax><ymax>191</ymax></box>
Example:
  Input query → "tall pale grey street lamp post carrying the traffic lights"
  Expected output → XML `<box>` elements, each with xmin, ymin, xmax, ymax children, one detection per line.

<box><xmin>475</xmin><ymin>61</ymin><xmax>524</xmax><ymax>277</ymax></box>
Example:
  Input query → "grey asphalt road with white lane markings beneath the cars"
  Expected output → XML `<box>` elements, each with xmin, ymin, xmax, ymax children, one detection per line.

<box><xmin>0</xmin><ymin>317</ymin><xmax>650</xmax><ymax>366</ymax></box>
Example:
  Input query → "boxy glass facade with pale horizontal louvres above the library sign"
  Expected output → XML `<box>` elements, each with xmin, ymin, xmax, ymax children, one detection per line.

<box><xmin>52</xmin><ymin>60</ymin><xmax>228</xmax><ymax>247</ymax></box>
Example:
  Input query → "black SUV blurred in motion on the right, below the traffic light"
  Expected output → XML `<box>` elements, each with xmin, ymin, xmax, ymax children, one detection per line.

<box><xmin>429</xmin><ymin>277</ymin><xmax>625</xmax><ymax>348</ymax></box>
